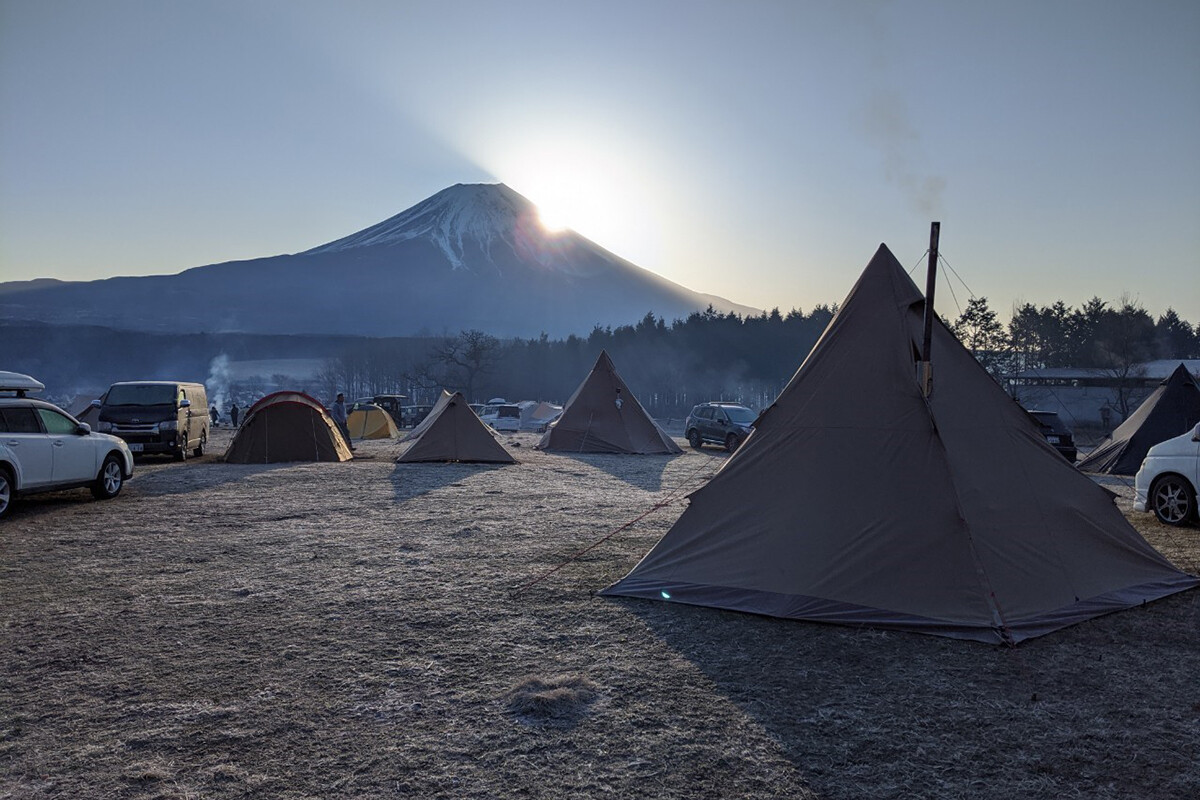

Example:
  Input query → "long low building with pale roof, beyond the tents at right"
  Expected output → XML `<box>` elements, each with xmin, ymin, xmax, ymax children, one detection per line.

<box><xmin>1008</xmin><ymin>359</ymin><xmax>1200</xmax><ymax>429</ymax></box>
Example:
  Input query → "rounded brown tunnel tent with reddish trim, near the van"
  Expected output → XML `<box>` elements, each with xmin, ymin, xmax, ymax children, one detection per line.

<box><xmin>224</xmin><ymin>391</ymin><xmax>354</xmax><ymax>464</ymax></box>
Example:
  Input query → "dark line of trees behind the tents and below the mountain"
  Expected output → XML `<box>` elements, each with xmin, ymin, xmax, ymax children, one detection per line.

<box><xmin>319</xmin><ymin>297</ymin><xmax>1200</xmax><ymax>417</ymax></box>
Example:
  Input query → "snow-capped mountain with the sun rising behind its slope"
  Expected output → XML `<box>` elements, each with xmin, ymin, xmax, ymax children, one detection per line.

<box><xmin>0</xmin><ymin>184</ymin><xmax>758</xmax><ymax>337</ymax></box>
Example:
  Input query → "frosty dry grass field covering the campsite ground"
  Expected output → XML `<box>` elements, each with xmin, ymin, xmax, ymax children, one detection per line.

<box><xmin>0</xmin><ymin>434</ymin><xmax>1200</xmax><ymax>800</ymax></box>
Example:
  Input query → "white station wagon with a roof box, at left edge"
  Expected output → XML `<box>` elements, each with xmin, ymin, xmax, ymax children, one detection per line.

<box><xmin>0</xmin><ymin>372</ymin><xmax>133</xmax><ymax>517</ymax></box>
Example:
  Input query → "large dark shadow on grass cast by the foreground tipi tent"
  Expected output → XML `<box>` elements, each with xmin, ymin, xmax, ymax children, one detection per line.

<box><xmin>614</xmin><ymin>591</ymin><xmax>1200</xmax><ymax>799</ymax></box>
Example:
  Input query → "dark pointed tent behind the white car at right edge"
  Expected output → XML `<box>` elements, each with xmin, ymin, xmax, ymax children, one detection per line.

<box><xmin>1079</xmin><ymin>363</ymin><xmax>1200</xmax><ymax>475</ymax></box>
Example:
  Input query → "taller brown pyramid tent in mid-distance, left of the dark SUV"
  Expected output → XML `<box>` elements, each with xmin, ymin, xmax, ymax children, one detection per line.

<box><xmin>538</xmin><ymin>351</ymin><xmax>683</xmax><ymax>453</ymax></box>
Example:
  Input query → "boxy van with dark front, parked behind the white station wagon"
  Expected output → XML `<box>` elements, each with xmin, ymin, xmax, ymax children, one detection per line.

<box><xmin>92</xmin><ymin>380</ymin><xmax>211</xmax><ymax>461</ymax></box>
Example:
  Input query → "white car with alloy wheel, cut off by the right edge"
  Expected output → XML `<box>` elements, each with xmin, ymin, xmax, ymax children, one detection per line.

<box><xmin>1133</xmin><ymin>425</ymin><xmax>1200</xmax><ymax>525</ymax></box>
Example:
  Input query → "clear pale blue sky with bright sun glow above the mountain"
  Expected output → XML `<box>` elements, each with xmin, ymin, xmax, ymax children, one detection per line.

<box><xmin>0</xmin><ymin>0</ymin><xmax>1200</xmax><ymax>323</ymax></box>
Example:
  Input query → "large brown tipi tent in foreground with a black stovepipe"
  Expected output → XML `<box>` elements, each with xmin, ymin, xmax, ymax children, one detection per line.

<box><xmin>602</xmin><ymin>246</ymin><xmax>1200</xmax><ymax>644</ymax></box>
